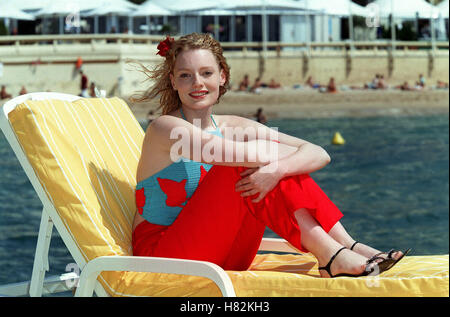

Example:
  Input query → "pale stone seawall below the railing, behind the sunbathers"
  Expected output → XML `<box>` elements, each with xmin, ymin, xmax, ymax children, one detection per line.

<box><xmin>0</xmin><ymin>42</ymin><xmax>449</xmax><ymax>96</ymax></box>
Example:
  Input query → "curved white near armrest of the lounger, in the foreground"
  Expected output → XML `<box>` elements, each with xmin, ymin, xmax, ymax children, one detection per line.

<box><xmin>75</xmin><ymin>256</ymin><xmax>236</xmax><ymax>297</ymax></box>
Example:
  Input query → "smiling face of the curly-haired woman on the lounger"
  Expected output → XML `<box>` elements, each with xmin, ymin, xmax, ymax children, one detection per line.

<box><xmin>170</xmin><ymin>49</ymin><xmax>226</xmax><ymax>110</ymax></box>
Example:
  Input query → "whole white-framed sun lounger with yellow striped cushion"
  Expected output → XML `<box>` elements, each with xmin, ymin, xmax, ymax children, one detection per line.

<box><xmin>0</xmin><ymin>93</ymin><xmax>449</xmax><ymax>297</ymax></box>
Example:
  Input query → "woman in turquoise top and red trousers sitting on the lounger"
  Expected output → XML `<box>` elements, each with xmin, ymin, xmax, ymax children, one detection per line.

<box><xmin>131</xmin><ymin>33</ymin><xmax>406</xmax><ymax>277</ymax></box>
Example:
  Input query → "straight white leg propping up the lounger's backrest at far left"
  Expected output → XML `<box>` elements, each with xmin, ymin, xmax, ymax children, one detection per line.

<box><xmin>29</xmin><ymin>208</ymin><xmax>53</xmax><ymax>297</ymax></box>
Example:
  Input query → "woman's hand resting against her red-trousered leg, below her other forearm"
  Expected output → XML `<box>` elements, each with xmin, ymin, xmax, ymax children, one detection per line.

<box><xmin>236</xmin><ymin>162</ymin><xmax>283</xmax><ymax>203</ymax></box>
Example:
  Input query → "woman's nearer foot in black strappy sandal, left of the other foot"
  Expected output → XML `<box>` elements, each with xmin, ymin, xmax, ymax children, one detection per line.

<box><xmin>318</xmin><ymin>248</ymin><xmax>381</xmax><ymax>277</ymax></box>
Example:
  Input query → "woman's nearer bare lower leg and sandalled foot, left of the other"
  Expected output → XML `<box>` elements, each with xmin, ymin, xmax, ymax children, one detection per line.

<box><xmin>294</xmin><ymin>208</ymin><xmax>375</xmax><ymax>277</ymax></box>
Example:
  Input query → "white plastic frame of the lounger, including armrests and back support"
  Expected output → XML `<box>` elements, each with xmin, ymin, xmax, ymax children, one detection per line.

<box><xmin>0</xmin><ymin>92</ymin><xmax>299</xmax><ymax>297</ymax></box>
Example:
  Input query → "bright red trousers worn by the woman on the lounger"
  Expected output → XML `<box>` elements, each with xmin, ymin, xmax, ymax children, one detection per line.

<box><xmin>133</xmin><ymin>165</ymin><xmax>343</xmax><ymax>270</ymax></box>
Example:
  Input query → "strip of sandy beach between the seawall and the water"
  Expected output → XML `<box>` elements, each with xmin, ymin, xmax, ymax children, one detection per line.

<box><xmin>124</xmin><ymin>88</ymin><xmax>449</xmax><ymax>121</ymax></box>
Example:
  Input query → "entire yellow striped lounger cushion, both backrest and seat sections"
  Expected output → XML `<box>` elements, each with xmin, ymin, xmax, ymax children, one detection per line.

<box><xmin>10</xmin><ymin>98</ymin><xmax>449</xmax><ymax>296</ymax></box>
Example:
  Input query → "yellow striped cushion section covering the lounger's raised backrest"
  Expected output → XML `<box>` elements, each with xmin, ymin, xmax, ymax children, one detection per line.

<box><xmin>9</xmin><ymin>98</ymin><xmax>144</xmax><ymax>290</ymax></box>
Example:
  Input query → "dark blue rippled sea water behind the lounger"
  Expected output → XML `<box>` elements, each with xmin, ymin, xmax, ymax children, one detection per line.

<box><xmin>0</xmin><ymin>115</ymin><xmax>449</xmax><ymax>285</ymax></box>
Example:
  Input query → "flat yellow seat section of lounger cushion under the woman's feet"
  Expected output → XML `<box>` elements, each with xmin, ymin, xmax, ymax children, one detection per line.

<box><xmin>110</xmin><ymin>254</ymin><xmax>449</xmax><ymax>297</ymax></box>
